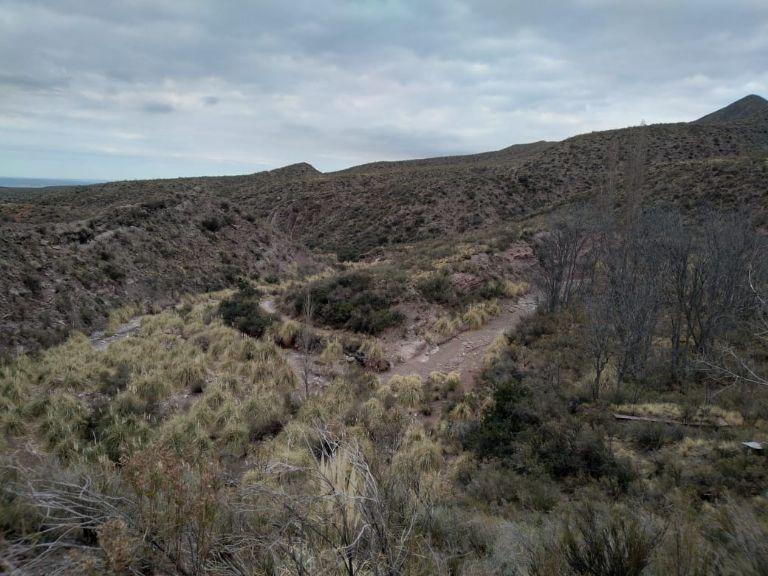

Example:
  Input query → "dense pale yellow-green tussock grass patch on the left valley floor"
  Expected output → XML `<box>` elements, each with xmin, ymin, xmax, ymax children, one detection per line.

<box><xmin>0</xmin><ymin>296</ymin><xmax>297</xmax><ymax>461</ymax></box>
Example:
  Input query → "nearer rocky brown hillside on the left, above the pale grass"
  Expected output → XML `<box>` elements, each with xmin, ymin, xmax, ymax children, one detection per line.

<box><xmin>0</xmin><ymin>192</ymin><xmax>318</xmax><ymax>350</ymax></box>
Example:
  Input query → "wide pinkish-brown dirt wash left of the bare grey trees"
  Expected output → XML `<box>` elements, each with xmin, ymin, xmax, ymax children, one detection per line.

<box><xmin>380</xmin><ymin>294</ymin><xmax>536</xmax><ymax>388</ymax></box>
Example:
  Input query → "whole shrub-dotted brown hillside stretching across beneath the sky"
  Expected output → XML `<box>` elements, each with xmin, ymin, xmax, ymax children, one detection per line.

<box><xmin>0</xmin><ymin>96</ymin><xmax>768</xmax><ymax>348</ymax></box>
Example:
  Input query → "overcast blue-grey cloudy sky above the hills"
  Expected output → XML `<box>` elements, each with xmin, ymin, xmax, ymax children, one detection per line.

<box><xmin>0</xmin><ymin>0</ymin><xmax>768</xmax><ymax>179</ymax></box>
